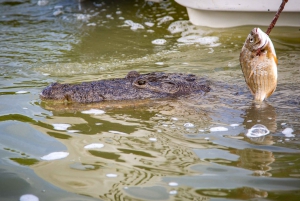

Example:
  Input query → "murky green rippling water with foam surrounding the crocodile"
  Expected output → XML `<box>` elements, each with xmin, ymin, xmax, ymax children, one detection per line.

<box><xmin>0</xmin><ymin>0</ymin><xmax>300</xmax><ymax>201</ymax></box>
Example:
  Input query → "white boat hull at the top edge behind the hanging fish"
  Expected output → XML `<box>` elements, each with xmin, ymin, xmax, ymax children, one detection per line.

<box><xmin>175</xmin><ymin>0</ymin><xmax>300</xmax><ymax>28</ymax></box>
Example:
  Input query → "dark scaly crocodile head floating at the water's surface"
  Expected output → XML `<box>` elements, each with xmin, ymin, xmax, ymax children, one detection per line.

<box><xmin>40</xmin><ymin>71</ymin><xmax>210</xmax><ymax>103</ymax></box>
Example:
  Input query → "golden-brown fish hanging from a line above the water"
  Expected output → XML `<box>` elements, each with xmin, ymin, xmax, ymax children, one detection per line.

<box><xmin>240</xmin><ymin>28</ymin><xmax>278</xmax><ymax>102</ymax></box>
